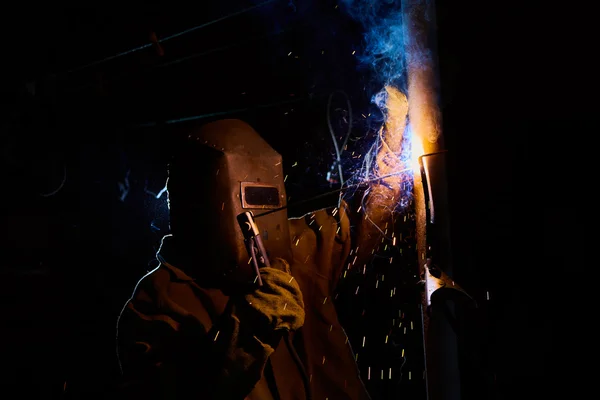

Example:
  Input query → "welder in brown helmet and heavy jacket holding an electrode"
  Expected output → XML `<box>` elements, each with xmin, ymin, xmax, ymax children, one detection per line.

<box><xmin>117</xmin><ymin>119</ymin><xmax>400</xmax><ymax>400</ymax></box>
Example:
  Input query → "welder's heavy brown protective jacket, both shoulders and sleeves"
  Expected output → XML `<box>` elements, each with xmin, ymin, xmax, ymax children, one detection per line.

<box><xmin>117</xmin><ymin>206</ymin><xmax>369</xmax><ymax>400</ymax></box>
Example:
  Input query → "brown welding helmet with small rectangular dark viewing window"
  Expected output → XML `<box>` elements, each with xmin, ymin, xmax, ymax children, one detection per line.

<box><xmin>167</xmin><ymin>119</ymin><xmax>291</xmax><ymax>285</ymax></box>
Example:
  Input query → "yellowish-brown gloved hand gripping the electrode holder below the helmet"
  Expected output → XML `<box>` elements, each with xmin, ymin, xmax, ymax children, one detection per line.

<box><xmin>238</xmin><ymin>258</ymin><xmax>304</xmax><ymax>334</ymax></box>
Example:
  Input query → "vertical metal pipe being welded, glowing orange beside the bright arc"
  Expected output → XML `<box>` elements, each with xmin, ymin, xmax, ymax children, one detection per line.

<box><xmin>401</xmin><ymin>0</ymin><xmax>461</xmax><ymax>400</ymax></box>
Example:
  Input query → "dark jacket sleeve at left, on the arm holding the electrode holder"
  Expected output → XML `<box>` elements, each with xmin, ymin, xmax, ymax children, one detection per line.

<box><xmin>117</xmin><ymin>267</ymin><xmax>274</xmax><ymax>399</ymax></box>
